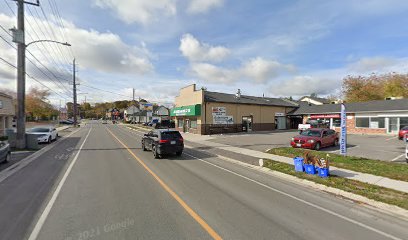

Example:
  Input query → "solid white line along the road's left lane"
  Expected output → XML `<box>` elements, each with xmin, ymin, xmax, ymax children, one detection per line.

<box><xmin>28</xmin><ymin>127</ymin><xmax>92</xmax><ymax>240</ymax></box>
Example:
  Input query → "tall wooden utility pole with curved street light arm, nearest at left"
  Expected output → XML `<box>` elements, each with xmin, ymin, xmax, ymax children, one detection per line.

<box><xmin>10</xmin><ymin>26</ymin><xmax>71</xmax><ymax>149</ymax></box>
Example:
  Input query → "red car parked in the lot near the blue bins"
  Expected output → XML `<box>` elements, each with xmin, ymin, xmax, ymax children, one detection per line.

<box><xmin>290</xmin><ymin>128</ymin><xmax>339</xmax><ymax>151</ymax></box>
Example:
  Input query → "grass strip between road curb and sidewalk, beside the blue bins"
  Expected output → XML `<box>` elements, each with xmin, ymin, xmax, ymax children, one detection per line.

<box><xmin>264</xmin><ymin>160</ymin><xmax>408</xmax><ymax>210</ymax></box>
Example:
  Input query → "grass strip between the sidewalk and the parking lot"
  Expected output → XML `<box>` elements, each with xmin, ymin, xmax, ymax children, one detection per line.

<box><xmin>267</xmin><ymin>147</ymin><xmax>408</xmax><ymax>182</ymax></box>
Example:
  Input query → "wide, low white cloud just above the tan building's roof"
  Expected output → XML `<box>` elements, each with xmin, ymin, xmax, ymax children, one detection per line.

<box><xmin>190</xmin><ymin>57</ymin><xmax>294</xmax><ymax>83</ymax></box>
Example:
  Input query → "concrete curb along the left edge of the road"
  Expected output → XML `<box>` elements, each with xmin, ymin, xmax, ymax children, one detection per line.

<box><xmin>0</xmin><ymin>127</ymin><xmax>80</xmax><ymax>183</ymax></box>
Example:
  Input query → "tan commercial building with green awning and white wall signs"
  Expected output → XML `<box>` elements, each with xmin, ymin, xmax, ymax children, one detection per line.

<box><xmin>170</xmin><ymin>84</ymin><xmax>298</xmax><ymax>134</ymax></box>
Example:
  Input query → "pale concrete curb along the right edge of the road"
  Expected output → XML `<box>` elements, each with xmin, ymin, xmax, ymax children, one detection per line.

<box><xmin>185</xmin><ymin>145</ymin><xmax>408</xmax><ymax>220</ymax></box>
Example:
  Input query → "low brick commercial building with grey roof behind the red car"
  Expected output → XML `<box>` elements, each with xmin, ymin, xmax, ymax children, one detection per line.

<box><xmin>288</xmin><ymin>99</ymin><xmax>408</xmax><ymax>134</ymax></box>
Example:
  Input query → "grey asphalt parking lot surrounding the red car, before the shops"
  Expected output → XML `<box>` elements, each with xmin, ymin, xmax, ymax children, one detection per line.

<box><xmin>209</xmin><ymin>130</ymin><xmax>405</xmax><ymax>162</ymax></box>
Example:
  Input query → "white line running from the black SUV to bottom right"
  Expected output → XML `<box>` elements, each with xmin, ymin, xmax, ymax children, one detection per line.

<box><xmin>184</xmin><ymin>153</ymin><xmax>402</xmax><ymax>240</ymax></box>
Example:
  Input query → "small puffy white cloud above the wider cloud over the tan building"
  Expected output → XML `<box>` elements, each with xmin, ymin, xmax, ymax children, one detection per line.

<box><xmin>179</xmin><ymin>34</ymin><xmax>230</xmax><ymax>62</ymax></box>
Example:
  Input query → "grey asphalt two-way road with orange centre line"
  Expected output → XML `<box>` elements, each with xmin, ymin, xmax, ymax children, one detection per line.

<box><xmin>0</xmin><ymin>123</ymin><xmax>408</xmax><ymax>240</ymax></box>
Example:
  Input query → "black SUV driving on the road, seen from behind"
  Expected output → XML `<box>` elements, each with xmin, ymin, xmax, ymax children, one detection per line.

<box><xmin>142</xmin><ymin>129</ymin><xmax>184</xmax><ymax>158</ymax></box>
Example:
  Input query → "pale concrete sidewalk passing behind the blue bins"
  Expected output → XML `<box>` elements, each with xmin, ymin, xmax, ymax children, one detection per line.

<box><xmin>182</xmin><ymin>133</ymin><xmax>408</xmax><ymax>193</ymax></box>
